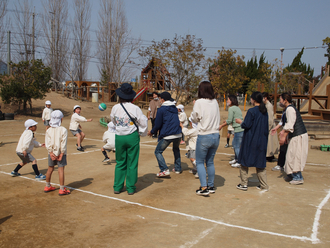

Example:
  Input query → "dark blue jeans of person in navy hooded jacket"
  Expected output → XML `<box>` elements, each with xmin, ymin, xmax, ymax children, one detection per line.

<box><xmin>155</xmin><ymin>138</ymin><xmax>181</xmax><ymax>171</ymax></box>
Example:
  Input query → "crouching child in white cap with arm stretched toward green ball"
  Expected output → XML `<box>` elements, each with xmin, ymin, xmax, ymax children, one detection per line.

<box><xmin>69</xmin><ymin>105</ymin><xmax>93</xmax><ymax>152</ymax></box>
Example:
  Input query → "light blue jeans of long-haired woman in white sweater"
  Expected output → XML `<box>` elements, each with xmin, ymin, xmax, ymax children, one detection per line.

<box><xmin>196</xmin><ymin>133</ymin><xmax>220</xmax><ymax>187</ymax></box>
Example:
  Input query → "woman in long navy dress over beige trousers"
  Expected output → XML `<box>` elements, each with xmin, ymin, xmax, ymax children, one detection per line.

<box><xmin>236</xmin><ymin>91</ymin><xmax>268</xmax><ymax>190</ymax></box>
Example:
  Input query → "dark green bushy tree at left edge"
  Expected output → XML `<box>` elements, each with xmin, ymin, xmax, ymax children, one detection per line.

<box><xmin>0</xmin><ymin>59</ymin><xmax>51</xmax><ymax>114</ymax></box>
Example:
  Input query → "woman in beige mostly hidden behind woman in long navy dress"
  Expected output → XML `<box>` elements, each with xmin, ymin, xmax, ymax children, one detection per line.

<box><xmin>262</xmin><ymin>92</ymin><xmax>279</xmax><ymax>162</ymax></box>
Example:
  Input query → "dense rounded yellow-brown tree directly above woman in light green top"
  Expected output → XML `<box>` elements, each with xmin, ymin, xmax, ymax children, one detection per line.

<box><xmin>209</xmin><ymin>48</ymin><xmax>247</xmax><ymax>95</ymax></box>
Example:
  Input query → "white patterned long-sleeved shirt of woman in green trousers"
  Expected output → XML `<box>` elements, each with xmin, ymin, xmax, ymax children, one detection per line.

<box><xmin>110</xmin><ymin>102</ymin><xmax>148</xmax><ymax>136</ymax></box>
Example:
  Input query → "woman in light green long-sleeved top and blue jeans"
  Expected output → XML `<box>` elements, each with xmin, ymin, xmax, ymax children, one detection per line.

<box><xmin>219</xmin><ymin>95</ymin><xmax>244</xmax><ymax>168</ymax></box>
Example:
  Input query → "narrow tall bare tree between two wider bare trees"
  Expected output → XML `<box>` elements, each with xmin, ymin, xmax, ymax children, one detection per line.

<box><xmin>73</xmin><ymin>0</ymin><xmax>91</xmax><ymax>81</ymax></box>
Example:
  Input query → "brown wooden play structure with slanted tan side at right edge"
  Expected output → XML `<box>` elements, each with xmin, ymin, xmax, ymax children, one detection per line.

<box><xmin>258</xmin><ymin>67</ymin><xmax>330</xmax><ymax>120</ymax></box>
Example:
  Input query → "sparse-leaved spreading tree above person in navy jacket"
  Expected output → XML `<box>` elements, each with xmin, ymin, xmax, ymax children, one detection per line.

<box><xmin>139</xmin><ymin>35</ymin><xmax>206</xmax><ymax>101</ymax></box>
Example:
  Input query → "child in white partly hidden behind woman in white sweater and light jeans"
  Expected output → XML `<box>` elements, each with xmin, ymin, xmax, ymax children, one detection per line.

<box><xmin>180</xmin><ymin>117</ymin><xmax>199</xmax><ymax>178</ymax></box>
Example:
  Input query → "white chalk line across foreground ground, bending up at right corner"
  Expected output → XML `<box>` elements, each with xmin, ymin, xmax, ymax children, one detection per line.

<box><xmin>0</xmin><ymin>171</ymin><xmax>324</xmax><ymax>244</ymax></box>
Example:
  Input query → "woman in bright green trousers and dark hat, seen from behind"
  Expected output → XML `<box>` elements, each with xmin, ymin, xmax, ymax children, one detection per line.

<box><xmin>110</xmin><ymin>83</ymin><xmax>148</xmax><ymax>195</ymax></box>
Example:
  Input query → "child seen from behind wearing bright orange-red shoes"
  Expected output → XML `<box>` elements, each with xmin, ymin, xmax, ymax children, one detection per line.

<box><xmin>44</xmin><ymin>110</ymin><xmax>70</xmax><ymax>196</ymax></box>
